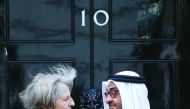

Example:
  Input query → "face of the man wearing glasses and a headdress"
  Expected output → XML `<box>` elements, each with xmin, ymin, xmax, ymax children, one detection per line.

<box><xmin>106</xmin><ymin>81</ymin><xmax>122</xmax><ymax>109</ymax></box>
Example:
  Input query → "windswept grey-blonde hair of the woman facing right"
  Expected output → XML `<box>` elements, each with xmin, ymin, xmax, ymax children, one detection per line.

<box><xmin>19</xmin><ymin>64</ymin><xmax>76</xmax><ymax>109</ymax></box>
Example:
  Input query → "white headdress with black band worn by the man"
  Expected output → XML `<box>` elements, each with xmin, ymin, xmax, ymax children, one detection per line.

<box><xmin>102</xmin><ymin>71</ymin><xmax>150</xmax><ymax>109</ymax></box>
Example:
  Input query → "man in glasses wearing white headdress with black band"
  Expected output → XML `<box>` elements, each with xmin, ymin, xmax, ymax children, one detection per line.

<box><xmin>102</xmin><ymin>71</ymin><xmax>150</xmax><ymax>109</ymax></box>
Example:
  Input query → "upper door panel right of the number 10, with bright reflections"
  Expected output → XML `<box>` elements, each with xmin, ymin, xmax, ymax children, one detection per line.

<box><xmin>110</xmin><ymin>0</ymin><xmax>177</xmax><ymax>41</ymax></box>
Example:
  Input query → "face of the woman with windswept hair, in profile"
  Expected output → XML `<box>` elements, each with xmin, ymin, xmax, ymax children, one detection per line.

<box><xmin>55</xmin><ymin>86</ymin><xmax>75</xmax><ymax>109</ymax></box>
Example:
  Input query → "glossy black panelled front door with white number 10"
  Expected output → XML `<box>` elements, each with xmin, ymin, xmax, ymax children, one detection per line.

<box><xmin>0</xmin><ymin>0</ymin><xmax>189</xmax><ymax>109</ymax></box>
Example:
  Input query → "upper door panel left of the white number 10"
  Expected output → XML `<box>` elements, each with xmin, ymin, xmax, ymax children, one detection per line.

<box><xmin>8</xmin><ymin>0</ymin><xmax>74</xmax><ymax>41</ymax></box>
